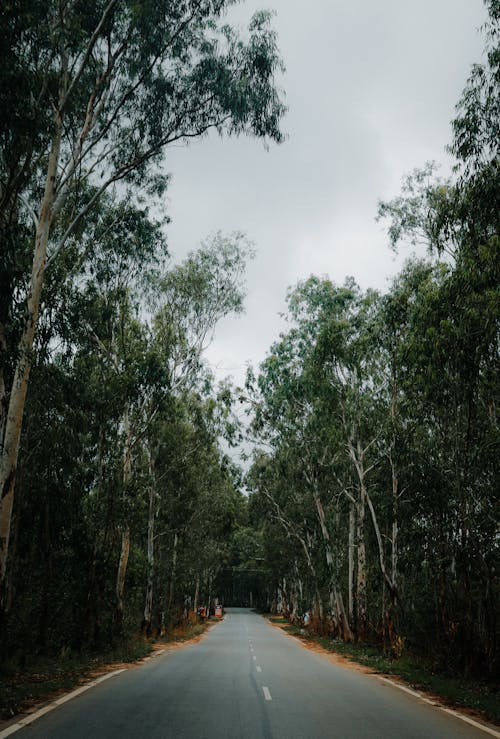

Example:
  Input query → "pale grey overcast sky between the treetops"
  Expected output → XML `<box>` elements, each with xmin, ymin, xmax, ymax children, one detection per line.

<box><xmin>162</xmin><ymin>0</ymin><xmax>486</xmax><ymax>390</ymax></box>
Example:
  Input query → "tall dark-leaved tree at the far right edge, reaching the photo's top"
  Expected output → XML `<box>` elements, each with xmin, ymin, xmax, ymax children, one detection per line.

<box><xmin>380</xmin><ymin>0</ymin><xmax>500</xmax><ymax>669</ymax></box>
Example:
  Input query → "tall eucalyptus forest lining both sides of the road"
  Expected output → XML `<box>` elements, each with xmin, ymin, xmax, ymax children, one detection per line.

<box><xmin>0</xmin><ymin>0</ymin><xmax>500</xmax><ymax>704</ymax></box>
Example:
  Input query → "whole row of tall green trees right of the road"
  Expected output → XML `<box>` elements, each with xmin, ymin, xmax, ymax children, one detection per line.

<box><xmin>247</xmin><ymin>2</ymin><xmax>500</xmax><ymax>676</ymax></box>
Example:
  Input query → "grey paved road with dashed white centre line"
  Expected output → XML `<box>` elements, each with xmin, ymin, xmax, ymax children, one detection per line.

<box><xmin>9</xmin><ymin>609</ymin><xmax>494</xmax><ymax>739</ymax></box>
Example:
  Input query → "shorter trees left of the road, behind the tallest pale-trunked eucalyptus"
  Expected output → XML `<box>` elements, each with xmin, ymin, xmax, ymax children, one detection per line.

<box><xmin>6</xmin><ymin>227</ymin><xmax>258</xmax><ymax>650</ymax></box>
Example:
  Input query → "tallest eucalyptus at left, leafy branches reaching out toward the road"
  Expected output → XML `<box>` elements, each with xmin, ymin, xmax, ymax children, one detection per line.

<box><xmin>0</xmin><ymin>0</ymin><xmax>284</xmax><ymax>580</ymax></box>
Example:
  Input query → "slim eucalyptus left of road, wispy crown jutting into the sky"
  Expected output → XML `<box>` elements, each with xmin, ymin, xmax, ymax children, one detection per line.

<box><xmin>135</xmin><ymin>233</ymin><xmax>253</xmax><ymax>630</ymax></box>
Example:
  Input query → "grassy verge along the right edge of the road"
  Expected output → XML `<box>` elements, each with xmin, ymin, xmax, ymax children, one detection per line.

<box><xmin>270</xmin><ymin>618</ymin><xmax>500</xmax><ymax>723</ymax></box>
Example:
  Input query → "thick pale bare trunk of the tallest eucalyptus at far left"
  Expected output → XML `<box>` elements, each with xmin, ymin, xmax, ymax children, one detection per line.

<box><xmin>0</xmin><ymin>120</ymin><xmax>61</xmax><ymax>593</ymax></box>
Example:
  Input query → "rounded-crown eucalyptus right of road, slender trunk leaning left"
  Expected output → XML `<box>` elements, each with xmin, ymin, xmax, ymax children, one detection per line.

<box><xmin>252</xmin><ymin>277</ymin><xmax>376</xmax><ymax>639</ymax></box>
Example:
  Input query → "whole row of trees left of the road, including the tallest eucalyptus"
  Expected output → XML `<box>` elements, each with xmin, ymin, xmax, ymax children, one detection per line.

<box><xmin>0</xmin><ymin>0</ymin><xmax>285</xmax><ymax>655</ymax></box>
